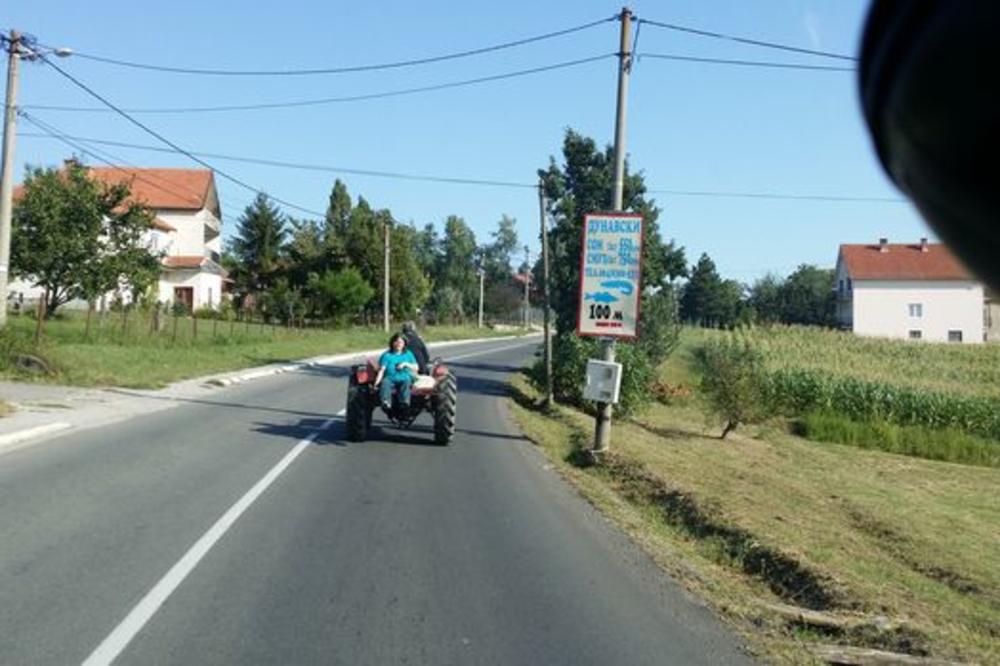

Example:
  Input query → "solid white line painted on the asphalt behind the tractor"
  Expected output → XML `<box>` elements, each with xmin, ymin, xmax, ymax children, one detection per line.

<box><xmin>83</xmin><ymin>409</ymin><xmax>347</xmax><ymax>666</ymax></box>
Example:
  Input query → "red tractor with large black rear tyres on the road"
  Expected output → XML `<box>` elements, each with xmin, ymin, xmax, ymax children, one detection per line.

<box><xmin>347</xmin><ymin>359</ymin><xmax>458</xmax><ymax>446</ymax></box>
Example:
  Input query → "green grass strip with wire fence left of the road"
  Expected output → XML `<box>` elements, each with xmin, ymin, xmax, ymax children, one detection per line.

<box><xmin>0</xmin><ymin>315</ymin><xmax>511</xmax><ymax>388</ymax></box>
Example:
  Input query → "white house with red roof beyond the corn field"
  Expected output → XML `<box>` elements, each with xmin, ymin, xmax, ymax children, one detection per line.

<box><xmin>835</xmin><ymin>238</ymin><xmax>984</xmax><ymax>343</ymax></box>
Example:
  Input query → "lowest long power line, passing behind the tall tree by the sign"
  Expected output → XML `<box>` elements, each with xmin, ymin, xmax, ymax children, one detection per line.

<box><xmin>18</xmin><ymin>132</ymin><xmax>906</xmax><ymax>203</ymax></box>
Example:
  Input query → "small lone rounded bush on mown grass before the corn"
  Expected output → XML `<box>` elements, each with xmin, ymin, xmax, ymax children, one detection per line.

<box><xmin>695</xmin><ymin>332</ymin><xmax>768</xmax><ymax>439</ymax></box>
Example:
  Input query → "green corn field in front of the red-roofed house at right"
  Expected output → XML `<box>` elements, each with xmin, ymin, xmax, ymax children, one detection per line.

<box><xmin>692</xmin><ymin>326</ymin><xmax>1000</xmax><ymax>440</ymax></box>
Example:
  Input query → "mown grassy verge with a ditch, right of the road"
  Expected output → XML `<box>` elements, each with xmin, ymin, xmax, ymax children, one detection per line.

<box><xmin>513</xmin><ymin>370</ymin><xmax>1000</xmax><ymax>663</ymax></box>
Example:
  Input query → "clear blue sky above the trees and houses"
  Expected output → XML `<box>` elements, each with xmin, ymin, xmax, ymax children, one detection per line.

<box><xmin>0</xmin><ymin>0</ymin><xmax>931</xmax><ymax>282</ymax></box>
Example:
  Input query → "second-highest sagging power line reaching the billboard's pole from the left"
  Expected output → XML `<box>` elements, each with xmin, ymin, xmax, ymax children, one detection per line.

<box><xmin>23</xmin><ymin>53</ymin><xmax>614</xmax><ymax>113</ymax></box>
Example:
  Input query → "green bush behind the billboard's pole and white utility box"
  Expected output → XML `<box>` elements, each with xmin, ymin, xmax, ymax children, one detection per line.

<box><xmin>531</xmin><ymin>288</ymin><xmax>680</xmax><ymax>415</ymax></box>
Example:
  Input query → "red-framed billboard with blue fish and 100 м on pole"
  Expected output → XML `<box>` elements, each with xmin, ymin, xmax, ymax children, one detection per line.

<box><xmin>576</xmin><ymin>213</ymin><xmax>643</xmax><ymax>338</ymax></box>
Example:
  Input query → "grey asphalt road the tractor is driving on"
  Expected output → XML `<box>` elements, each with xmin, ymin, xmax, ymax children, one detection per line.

<box><xmin>0</xmin><ymin>340</ymin><xmax>749</xmax><ymax>665</ymax></box>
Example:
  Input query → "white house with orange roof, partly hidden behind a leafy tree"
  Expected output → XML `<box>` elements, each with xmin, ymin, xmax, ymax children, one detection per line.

<box><xmin>11</xmin><ymin>167</ymin><xmax>230</xmax><ymax>310</ymax></box>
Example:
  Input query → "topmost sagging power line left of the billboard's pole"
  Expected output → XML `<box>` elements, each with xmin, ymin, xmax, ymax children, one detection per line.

<box><xmin>48</xmin><ymin>16</ymin><xmax>617</xmax><ymax>76</ymax></box>
